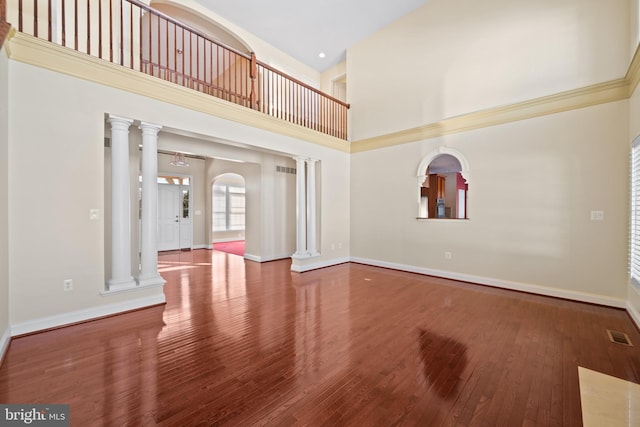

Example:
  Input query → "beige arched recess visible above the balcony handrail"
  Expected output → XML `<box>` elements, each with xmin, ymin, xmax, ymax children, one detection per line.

<box><xmin>150</xmin><ymin>0</ymin><xmax>253</xmax><ymax>55</ymax></box>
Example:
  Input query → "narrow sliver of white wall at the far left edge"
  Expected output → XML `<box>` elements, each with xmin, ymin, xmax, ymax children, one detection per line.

<box><xmin>0</xmin><ymin>48</ymin><xmax>10</xmax><ymax>354</ymax></box>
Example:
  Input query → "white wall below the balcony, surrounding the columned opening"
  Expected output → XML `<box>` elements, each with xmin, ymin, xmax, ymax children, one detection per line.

<box><xmin>5</xmin><ymin>61</ymin><xmax>349</xmax><ymax>330</ymax></box>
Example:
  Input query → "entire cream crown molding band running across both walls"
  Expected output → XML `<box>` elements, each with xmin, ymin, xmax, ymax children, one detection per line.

<box><xmin>4</xmin><ymin>28</ymin><xmax>640</xmax><ymax>153</ymax></box>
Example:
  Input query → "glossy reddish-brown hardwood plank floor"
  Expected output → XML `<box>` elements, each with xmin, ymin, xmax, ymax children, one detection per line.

<box><xmin>0</xmin><ymin>250</ymin><xmax>640</xmax><ymax>426</ymax></box>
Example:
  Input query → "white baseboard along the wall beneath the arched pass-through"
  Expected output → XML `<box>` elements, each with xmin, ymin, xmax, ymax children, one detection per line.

<box><xmin>351</xmin><ymin>257</ymin><xmax>627</xmax><ymax>308</ymax></box>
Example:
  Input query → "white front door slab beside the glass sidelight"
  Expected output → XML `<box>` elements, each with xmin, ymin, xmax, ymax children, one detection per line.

<box><xmin>158</xmin><ymin>184</ymin><xmax>182</xmax><ymax>251</ymax></box>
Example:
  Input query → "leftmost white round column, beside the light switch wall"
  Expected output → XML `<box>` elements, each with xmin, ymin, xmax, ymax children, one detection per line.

<box><xmin>107</xmin><ymin>115</ymin><xmax>136</xmax><ymax>291</ymax></box>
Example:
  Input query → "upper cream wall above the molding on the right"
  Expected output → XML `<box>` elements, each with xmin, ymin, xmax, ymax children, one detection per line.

<box><xmin>347</xmin><ymin>0</ymin><xmax>631</xmax><ymax>140</ymax></box>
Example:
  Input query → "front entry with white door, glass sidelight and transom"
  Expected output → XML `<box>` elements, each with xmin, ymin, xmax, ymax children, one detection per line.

<box><xmin>158</xmin><ymin>176</ymin><xmax>193</xmax><ymax>251</ymax></box>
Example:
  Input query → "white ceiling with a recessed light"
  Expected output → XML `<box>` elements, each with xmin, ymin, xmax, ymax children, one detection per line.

<box><xmin>196</xmin><ymin>0</ymin><xmax>427</xmax><ymax>71</ymax></box>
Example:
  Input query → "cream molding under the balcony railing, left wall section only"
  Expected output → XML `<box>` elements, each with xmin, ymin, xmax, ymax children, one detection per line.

<box><xmin>5</xmin><ymin>32</ymin><xmax>349</xmax><ymax>153</ymax></box>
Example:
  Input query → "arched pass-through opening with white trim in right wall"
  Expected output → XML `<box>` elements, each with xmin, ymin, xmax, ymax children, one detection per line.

<box><xmin>416</xmin><ymin>147</ymin><xmax>469</xmax><ymax>219</ymax></box>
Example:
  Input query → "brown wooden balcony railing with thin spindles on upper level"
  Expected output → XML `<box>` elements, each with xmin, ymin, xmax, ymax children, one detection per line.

<box><xmin>0</xmin><ymin>0</ymin><xmax>349</xmax><ymax>140</ymax></box>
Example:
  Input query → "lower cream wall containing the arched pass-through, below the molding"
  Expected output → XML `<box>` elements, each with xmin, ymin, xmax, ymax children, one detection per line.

<box><xmin>351</xmin><ymin>101</ymin><xmax>629</xmax><ymax>305</ymax></box>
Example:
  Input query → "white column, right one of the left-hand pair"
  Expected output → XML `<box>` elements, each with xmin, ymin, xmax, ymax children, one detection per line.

<box><xmin>138</xmin><ymin>122</ymin><xmax>165</xmax><ymax>286</ymax></box>
